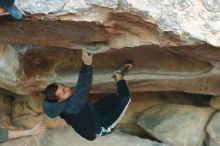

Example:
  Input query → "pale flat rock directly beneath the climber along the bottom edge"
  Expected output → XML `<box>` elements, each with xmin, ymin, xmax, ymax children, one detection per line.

<box><xmin>1</xmin><ymin>127</ymin><xmax>169</xmax><ymax>146</ymax></box>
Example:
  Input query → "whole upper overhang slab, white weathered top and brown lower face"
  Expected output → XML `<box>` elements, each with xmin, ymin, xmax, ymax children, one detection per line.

<box><xmin>0</xmin><ymin>0</ymin><xmax>220</xmax><ymax>49</ymax></box>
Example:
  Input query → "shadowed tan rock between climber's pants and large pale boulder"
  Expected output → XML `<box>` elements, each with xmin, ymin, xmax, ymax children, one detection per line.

<box><xmin>117</xmin><ymin>92</ymin><xmax>167</xmax><ymax>137</ymax></box>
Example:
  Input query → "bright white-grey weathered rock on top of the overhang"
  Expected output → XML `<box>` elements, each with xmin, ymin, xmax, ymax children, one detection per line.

<box><xmin>10</xmin><ymin>0</ymin><xmax>220</xmax><ymax>46</ymax></box>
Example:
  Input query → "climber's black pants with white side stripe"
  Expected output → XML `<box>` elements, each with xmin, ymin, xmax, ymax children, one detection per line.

<box><xmin>95</xmin><ymin>80</ymin><xmax>131</xmax><ymax>136</ymax></box>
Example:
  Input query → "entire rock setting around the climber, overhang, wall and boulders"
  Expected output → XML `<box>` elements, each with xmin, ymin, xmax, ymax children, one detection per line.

<box><xmin>0</xmin><ymin>0</ymin><xmax>220</xmax><ymax>146</ymax></box>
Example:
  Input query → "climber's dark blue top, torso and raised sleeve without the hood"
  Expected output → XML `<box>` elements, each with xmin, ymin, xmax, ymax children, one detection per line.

<box><xmin>60</xmin><ymin>64</ymin><xmax>101</xmax><ymax>140</ymax></box>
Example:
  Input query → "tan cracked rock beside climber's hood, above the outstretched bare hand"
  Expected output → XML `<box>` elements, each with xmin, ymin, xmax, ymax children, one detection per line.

<box><xmin>12</xmin><ymin>94</ymin><xmax>67</xmax><ymax>128</ymax></box>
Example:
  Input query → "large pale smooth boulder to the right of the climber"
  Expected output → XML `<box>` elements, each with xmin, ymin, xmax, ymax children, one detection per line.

<box><xmin>137</xmin><ymin>104</ymin><xmax>213</xmax><ymax>146</ymax></box>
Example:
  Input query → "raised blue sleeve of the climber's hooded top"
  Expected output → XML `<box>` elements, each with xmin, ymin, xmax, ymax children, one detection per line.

<box><xmin>63</xmin><ymin>64</ymin><xmax>93</xmax><ymax>114</ymax></box>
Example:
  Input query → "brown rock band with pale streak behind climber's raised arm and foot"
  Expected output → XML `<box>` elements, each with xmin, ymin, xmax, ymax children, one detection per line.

<box><xmin>0</xmin><ymin>45</ymin><xmax>220</xmax><ymax>95</ymax></box>
